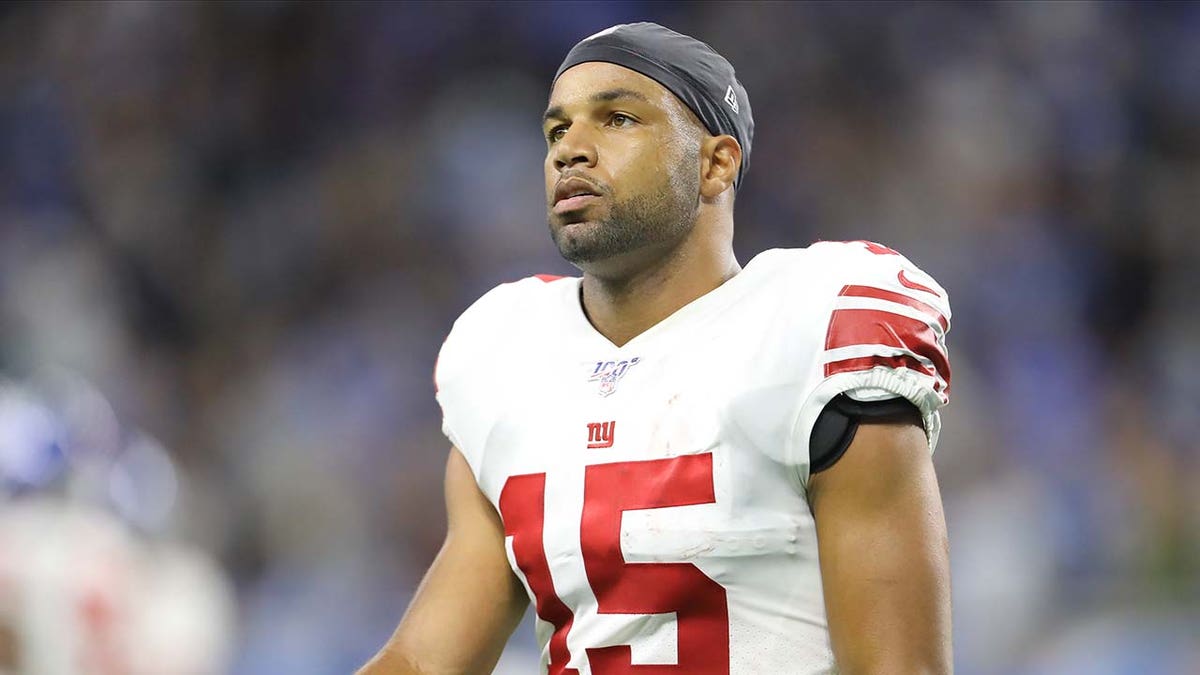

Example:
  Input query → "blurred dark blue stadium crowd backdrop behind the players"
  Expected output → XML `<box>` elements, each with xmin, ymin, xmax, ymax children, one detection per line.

<box><xmin>0</xmin><ymin>1</ymin><xmax>1200</xmax><ymax>675</ymax></box>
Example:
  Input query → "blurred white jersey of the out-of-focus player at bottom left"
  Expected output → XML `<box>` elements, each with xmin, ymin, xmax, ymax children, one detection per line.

<box><xmin>0</xmin><ymin>497</ymin><xmax>235</xmax><ymax>675</ymax></box>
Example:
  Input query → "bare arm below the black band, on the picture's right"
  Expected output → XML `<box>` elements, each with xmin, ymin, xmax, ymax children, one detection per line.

<box><xmin>809</xmin><ymin>423</ymin><xmax>953</xmax><ymax>675</ymax></box>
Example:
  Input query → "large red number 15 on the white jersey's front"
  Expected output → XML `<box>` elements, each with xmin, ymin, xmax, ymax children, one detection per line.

<box><xmin>500</xmin><ymin>454</ymin><xmax>730</xmax><ymax>675</ymax></box>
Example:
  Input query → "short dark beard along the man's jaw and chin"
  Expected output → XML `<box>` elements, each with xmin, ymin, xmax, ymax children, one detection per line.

<box><xmin>550</xmin><ymin>166</ymin><xmax>700</xmax><ymax>265</ymax></box>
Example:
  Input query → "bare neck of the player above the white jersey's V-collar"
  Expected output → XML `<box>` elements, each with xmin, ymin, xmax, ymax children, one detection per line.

<box><xmin>582</xmin><ymin>233</ymin><xmax>742</xmax><ymax>347</ymax></box>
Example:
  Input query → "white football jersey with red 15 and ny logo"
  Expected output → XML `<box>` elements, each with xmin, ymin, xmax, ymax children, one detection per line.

<box><xmin>436</xmin><ymin>241</ymin><xmax>950</xmax><ymax>675</ymax></box>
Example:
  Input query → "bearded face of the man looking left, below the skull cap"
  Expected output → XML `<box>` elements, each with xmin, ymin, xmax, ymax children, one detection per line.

<box><xmin>542</xmin><ymin>62</ymin><xmax>702</xmax><ymax>268</ymax></box>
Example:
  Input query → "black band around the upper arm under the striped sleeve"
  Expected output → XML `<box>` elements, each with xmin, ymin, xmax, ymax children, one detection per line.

<box><xmin>809</xmin><ymin>394</ymin><xmax>923</xmax><ymax>473</ymax></box>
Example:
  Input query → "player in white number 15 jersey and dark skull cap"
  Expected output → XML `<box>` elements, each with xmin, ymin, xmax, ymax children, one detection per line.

<box><xmin>360</xmin><ymin>23</ymin><xmax>950</xmax><ymax>675</ymax></box>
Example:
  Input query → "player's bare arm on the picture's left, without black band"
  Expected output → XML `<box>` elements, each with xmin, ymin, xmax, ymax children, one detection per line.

<box><xmin>359</xmin><ymin>448</ymin><xmax>528</xmax><ymax>675</ymax></box>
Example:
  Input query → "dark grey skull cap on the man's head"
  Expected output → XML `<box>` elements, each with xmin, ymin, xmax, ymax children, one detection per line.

<box><xmin>554</xmin><ymin>23</ymin><xmax>754</xmax><ymax>185</ymax></box>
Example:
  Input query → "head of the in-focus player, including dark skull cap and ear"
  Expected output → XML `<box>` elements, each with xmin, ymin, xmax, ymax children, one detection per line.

<box><xmin>542</xmin><ymin>24</ymin><xmax>754</xmax><ymax>271</ymax></box>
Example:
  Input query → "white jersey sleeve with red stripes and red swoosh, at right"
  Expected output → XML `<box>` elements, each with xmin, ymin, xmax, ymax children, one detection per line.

<box><xmin>792</xmin><ymin>241</ymin><xmax>950</xmax><ymax>482</ymax></box>
